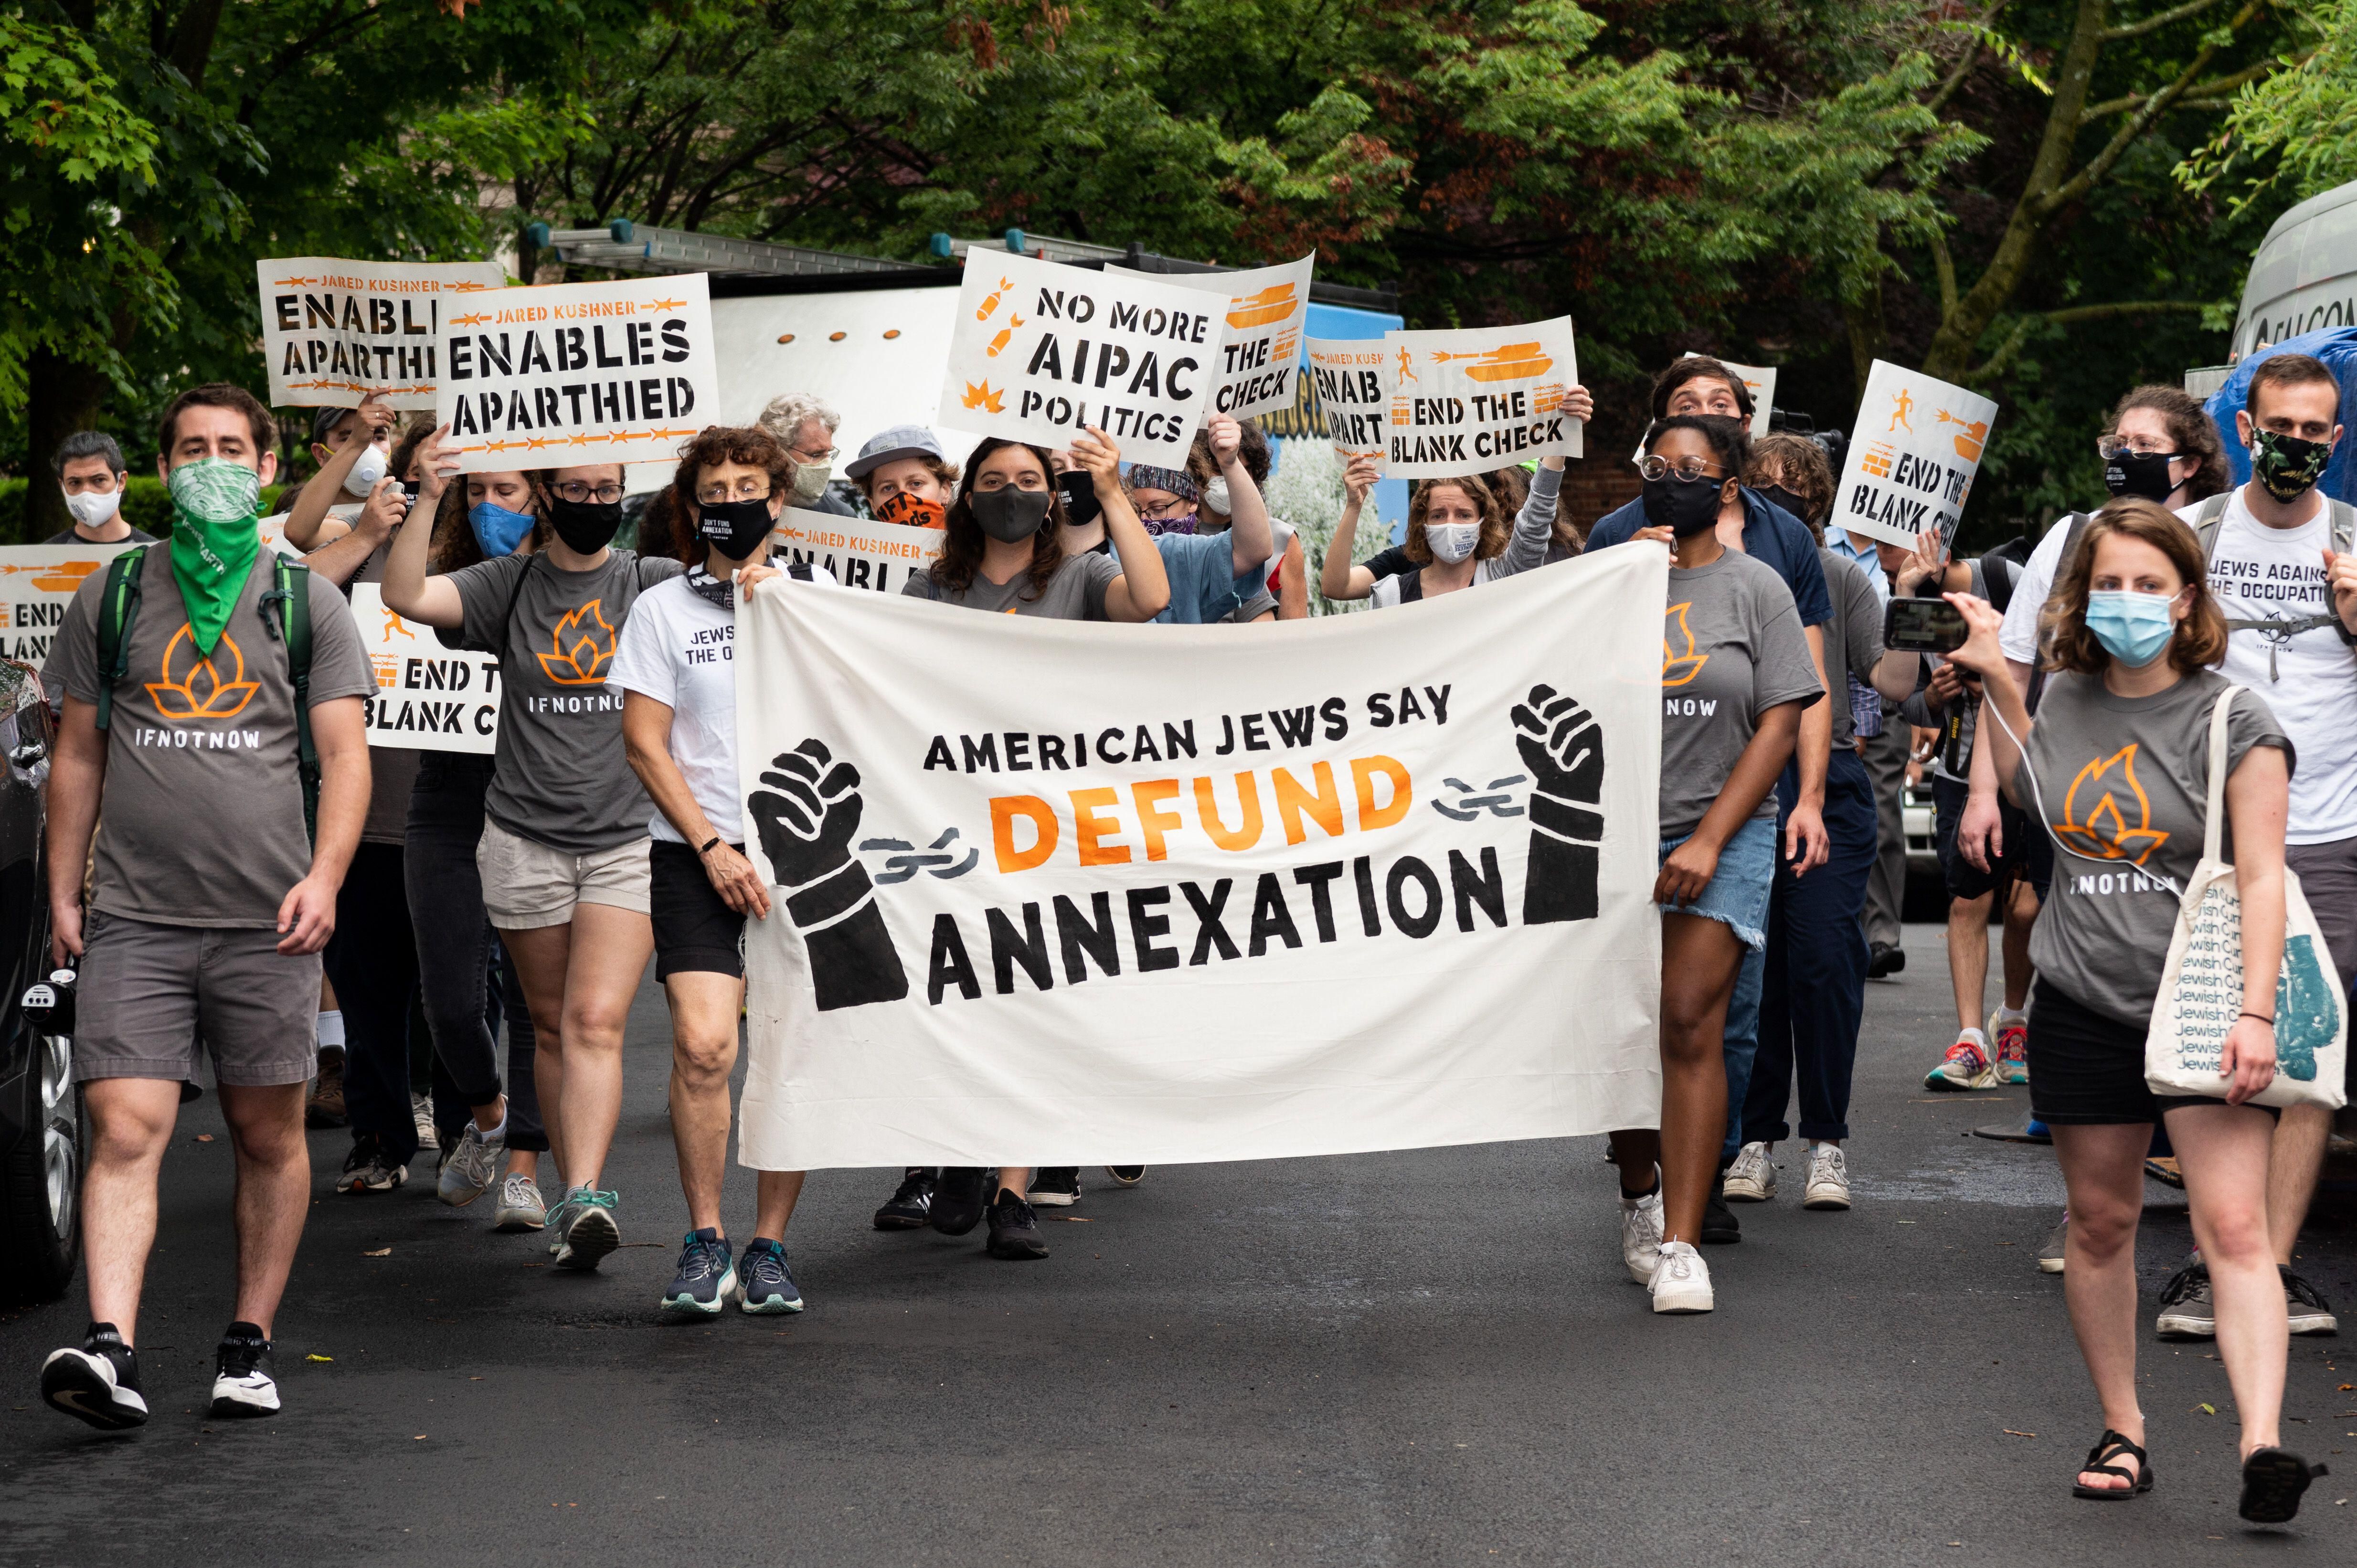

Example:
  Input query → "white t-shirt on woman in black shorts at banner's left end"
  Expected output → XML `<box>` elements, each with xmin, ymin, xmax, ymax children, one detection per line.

<box><xmin>606</xmin><ymin>566</ymin><xmax>834</xmax><ymax>844</ymax></box>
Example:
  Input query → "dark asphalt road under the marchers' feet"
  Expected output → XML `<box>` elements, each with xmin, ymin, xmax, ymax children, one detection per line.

<box><xmin>0</xmin><ymin>927</ymin><xmax>2357</xmax><ymax>1568</ymax></box>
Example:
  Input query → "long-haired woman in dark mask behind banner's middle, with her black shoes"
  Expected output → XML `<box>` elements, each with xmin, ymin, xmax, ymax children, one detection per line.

<box><xmin>879</xmin><ymin>424</ymin><xmax>1164</xmax><ymax>1259</ymax></box>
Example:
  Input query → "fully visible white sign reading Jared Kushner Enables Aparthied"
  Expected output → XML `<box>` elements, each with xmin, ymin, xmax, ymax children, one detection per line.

<box><xmin>434</xmin><ymin>271</ymin><xmax>719</xmax><ymax>474</ymax></box>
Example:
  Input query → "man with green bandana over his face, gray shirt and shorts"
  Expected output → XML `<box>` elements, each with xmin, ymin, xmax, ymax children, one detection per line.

<box><xmin>40</xmin><ymin>384</ymin><xmax>375</xmax><ymax>1429</ymax></box>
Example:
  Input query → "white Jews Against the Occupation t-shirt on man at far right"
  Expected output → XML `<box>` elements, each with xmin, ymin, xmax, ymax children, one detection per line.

<box><xmin>2178</xmin><ymin>488</ymin><xmax>2357</xmax><ymax>844</ymax></box>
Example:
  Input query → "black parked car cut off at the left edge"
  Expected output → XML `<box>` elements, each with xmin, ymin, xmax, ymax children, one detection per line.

<box><xmin>0</xmin><ymin>660</ymin><xmax>85</xmax><ymax>1304</ymax></box>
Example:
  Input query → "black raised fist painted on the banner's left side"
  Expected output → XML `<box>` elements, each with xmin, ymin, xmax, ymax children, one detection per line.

<box><xmin>745</xmin><ymin>741</ymin><xmax>907</xmax><ymax>1012</ymax></box>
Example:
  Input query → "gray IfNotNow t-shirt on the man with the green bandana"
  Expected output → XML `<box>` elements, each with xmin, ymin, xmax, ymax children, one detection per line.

<box><xmin>50</xmin><ymin>545</ymin><xmax>377</xmax><ymax>929</ymax></box>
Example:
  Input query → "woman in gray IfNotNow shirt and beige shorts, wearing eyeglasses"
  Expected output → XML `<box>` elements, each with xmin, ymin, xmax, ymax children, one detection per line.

<box><xmin>384</xmin><ymin>432</ymin><xmax>683</xmax><ymax>1269</ymax></box>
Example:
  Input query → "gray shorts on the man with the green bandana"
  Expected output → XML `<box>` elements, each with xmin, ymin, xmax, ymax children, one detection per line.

<box><xmin>73</xmin><ymin>910</ymin><xmax>318</xmax><ymax>1090</ymax></box>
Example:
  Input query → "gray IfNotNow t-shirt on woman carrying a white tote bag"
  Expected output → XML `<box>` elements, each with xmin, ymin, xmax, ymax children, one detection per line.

<box><xmin>2015</xmin><ymin>669</ymin><xmax>2296</xmax><ymax>1028</ymax></box>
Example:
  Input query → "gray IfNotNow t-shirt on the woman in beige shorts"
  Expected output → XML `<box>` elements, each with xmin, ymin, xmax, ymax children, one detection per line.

<box><xmin>450</xmin><ymin>550</ymin><xmax>686</xmax><ymax>854</ymax></box>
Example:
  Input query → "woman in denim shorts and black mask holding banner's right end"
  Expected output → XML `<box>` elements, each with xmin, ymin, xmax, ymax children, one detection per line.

<box><xmin>1603</xmin><ymin>415</ymin><xmax>1824</xmax><ymax>1314</ymax></box>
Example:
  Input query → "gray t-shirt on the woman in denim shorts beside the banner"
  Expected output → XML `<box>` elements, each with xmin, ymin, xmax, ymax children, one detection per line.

<box><xmin>1662</xmin><ymin>550</ymin><xmax>1824</xmax><ymax>839</ymax></box>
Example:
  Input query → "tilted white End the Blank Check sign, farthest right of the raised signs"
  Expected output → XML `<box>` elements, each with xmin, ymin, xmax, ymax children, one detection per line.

<box><xmin>1824</xmin><ymin>361</ymin><xmax>1996</xmax><ymax>545</ymax></box>
